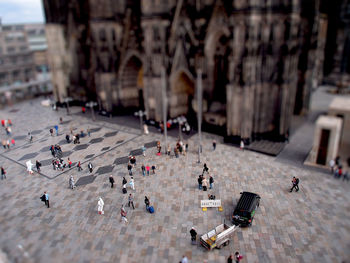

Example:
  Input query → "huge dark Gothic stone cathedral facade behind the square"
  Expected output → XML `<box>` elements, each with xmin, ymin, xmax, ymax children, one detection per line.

<box><xmin>43</xmin><ymin>0</ymin><xmax>327</xmax><ymax>142</ymax></box>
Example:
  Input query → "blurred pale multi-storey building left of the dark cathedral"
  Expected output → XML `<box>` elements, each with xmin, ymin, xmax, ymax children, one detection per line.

<box><xmin>0</xmin><ymin>19</ymin><xmax>51</xmax><ymax>106</ymax></box>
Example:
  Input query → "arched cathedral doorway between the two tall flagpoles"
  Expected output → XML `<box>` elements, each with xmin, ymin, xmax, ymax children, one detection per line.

<box><xmin>169</xmin><ymin>70</ymin><xmax>194</xmax><ymax>118</ymax></box>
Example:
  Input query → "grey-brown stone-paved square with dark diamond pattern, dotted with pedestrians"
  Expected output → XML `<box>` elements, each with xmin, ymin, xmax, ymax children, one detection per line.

<box><xmin>0</xmin><ymin>100</ymin><xmax>350</xmax><ymax>262</ymax></box>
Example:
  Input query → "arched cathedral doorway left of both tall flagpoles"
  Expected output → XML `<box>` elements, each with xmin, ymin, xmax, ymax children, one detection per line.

<box><xmin>120</xmin><ymin>55</ymin><xmax>144</xmax><ymax>110</ymax></box>
